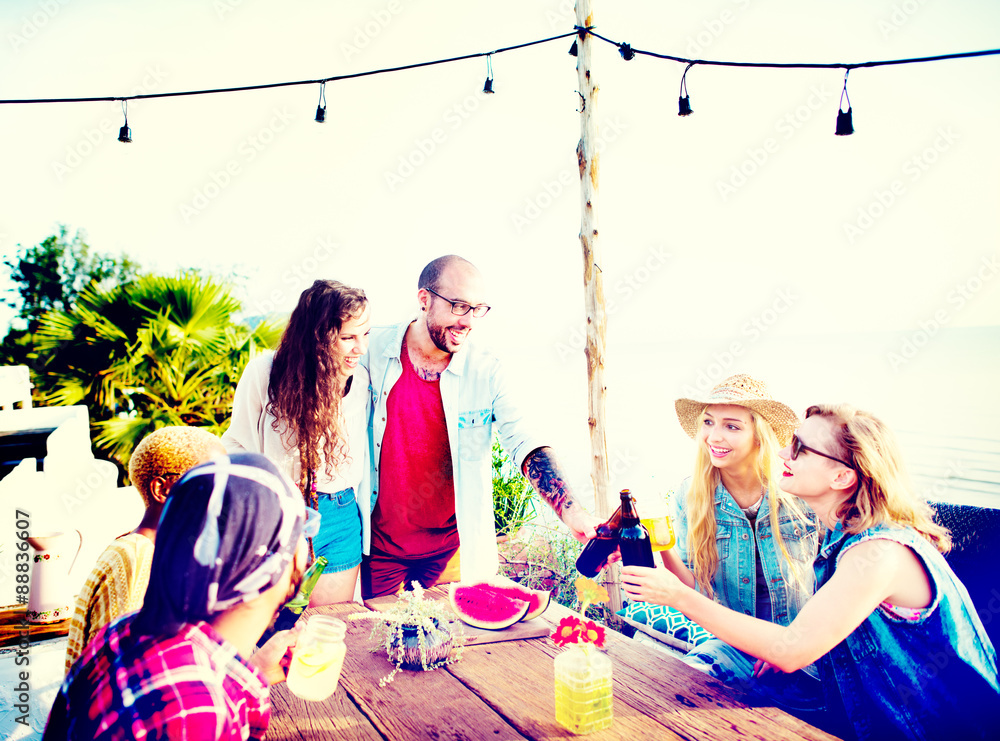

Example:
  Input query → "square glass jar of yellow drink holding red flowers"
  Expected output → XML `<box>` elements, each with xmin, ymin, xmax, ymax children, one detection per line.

<box><xmin>555</xmin><ymin>643</ymin><xmax>613</xmax><ymax>734</ymax></box>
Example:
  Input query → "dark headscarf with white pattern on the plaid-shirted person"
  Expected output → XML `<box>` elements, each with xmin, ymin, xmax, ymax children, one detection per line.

<box><xmin>134</xmin><ymin>453</ymin><xmax>319</xmax><ymax>635</ymax></box>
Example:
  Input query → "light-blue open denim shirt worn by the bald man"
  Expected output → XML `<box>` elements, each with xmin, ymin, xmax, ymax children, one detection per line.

<box><xmin>358</xmin><ymin>321</ymin><xmax>546</xmax><ymax>580</ymax></box>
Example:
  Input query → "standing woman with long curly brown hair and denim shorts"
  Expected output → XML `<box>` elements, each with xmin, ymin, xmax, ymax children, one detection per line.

<box><xmin>222</xmin><ymin>280</ymin><xmax>371</xmax><ymax>605</ymax></box>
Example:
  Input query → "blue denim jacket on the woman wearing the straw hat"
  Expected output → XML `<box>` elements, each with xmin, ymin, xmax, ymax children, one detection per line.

<box><xmin>670</xmin><ymin>478</ymin><xmax>819</xmax><ymax>625</ymax></box>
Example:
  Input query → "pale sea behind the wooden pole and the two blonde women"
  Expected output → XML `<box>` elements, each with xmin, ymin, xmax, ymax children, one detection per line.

<box><xmin>490</xmin><ymin>327</ymin><xmax>1000</xmax><ymax>517</ymax></box>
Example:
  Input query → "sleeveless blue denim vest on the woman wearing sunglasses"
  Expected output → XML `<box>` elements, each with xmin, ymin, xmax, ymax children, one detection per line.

<box><xmin>815</xmin><ymin>524</ymin><xmax>1000</xmax><ymax>740</ymax></box>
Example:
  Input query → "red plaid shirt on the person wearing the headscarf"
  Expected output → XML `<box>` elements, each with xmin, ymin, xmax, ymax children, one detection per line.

<box><xmin>43</xmin><ymin>614</ymin><xmax>271</xmax><ymax>741</ymax></box>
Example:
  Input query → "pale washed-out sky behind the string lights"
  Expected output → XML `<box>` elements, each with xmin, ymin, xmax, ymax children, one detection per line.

<box><xmin>0</xmin><ymin>0</ymin><xmax>1000</xmax><ymax>502</ymax></box>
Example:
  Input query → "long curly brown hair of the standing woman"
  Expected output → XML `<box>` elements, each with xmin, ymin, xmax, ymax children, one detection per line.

<box><xmin>267</xmin><ymin>280</ymin><xmax>368</xmax><ymax>507</ymax></box>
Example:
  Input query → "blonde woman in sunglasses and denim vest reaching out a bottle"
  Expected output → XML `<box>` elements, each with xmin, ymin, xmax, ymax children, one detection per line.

<box><xmin>622</xmin><ymin>405</ymin><xmax>1000</xmax><ymax>739</ymax></box>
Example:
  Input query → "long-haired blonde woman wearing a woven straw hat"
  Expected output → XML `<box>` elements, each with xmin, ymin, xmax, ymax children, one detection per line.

<box><xmin>661</xmin><ymin>374</ymin><xmax>820</xmax><ymax>711</ymax></box>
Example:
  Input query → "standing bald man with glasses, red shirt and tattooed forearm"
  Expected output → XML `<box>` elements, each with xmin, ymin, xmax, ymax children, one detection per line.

<box><xmin>359</xmin><ymin>255</ymin><xmax>600</xmax><ymax>599</ymax></box>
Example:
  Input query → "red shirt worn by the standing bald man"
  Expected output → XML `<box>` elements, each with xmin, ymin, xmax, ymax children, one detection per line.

<box><xmin>372</xmin><ymin>337</ymin><xmax>458</xmax><ymax>558</ymax></box>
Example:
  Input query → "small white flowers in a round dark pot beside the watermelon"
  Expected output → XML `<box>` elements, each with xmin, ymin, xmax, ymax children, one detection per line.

<box><xmin>349</xmin><ymin>582</ymin><xmax>462</xmax><ymax>687</ymax></box>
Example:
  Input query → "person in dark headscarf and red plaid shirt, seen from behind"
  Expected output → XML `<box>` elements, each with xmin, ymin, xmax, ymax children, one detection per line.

<box><xmin>43</xmin><ymin>454</ymin><xmax>319</xmax><ymax>741</ymax></box>
